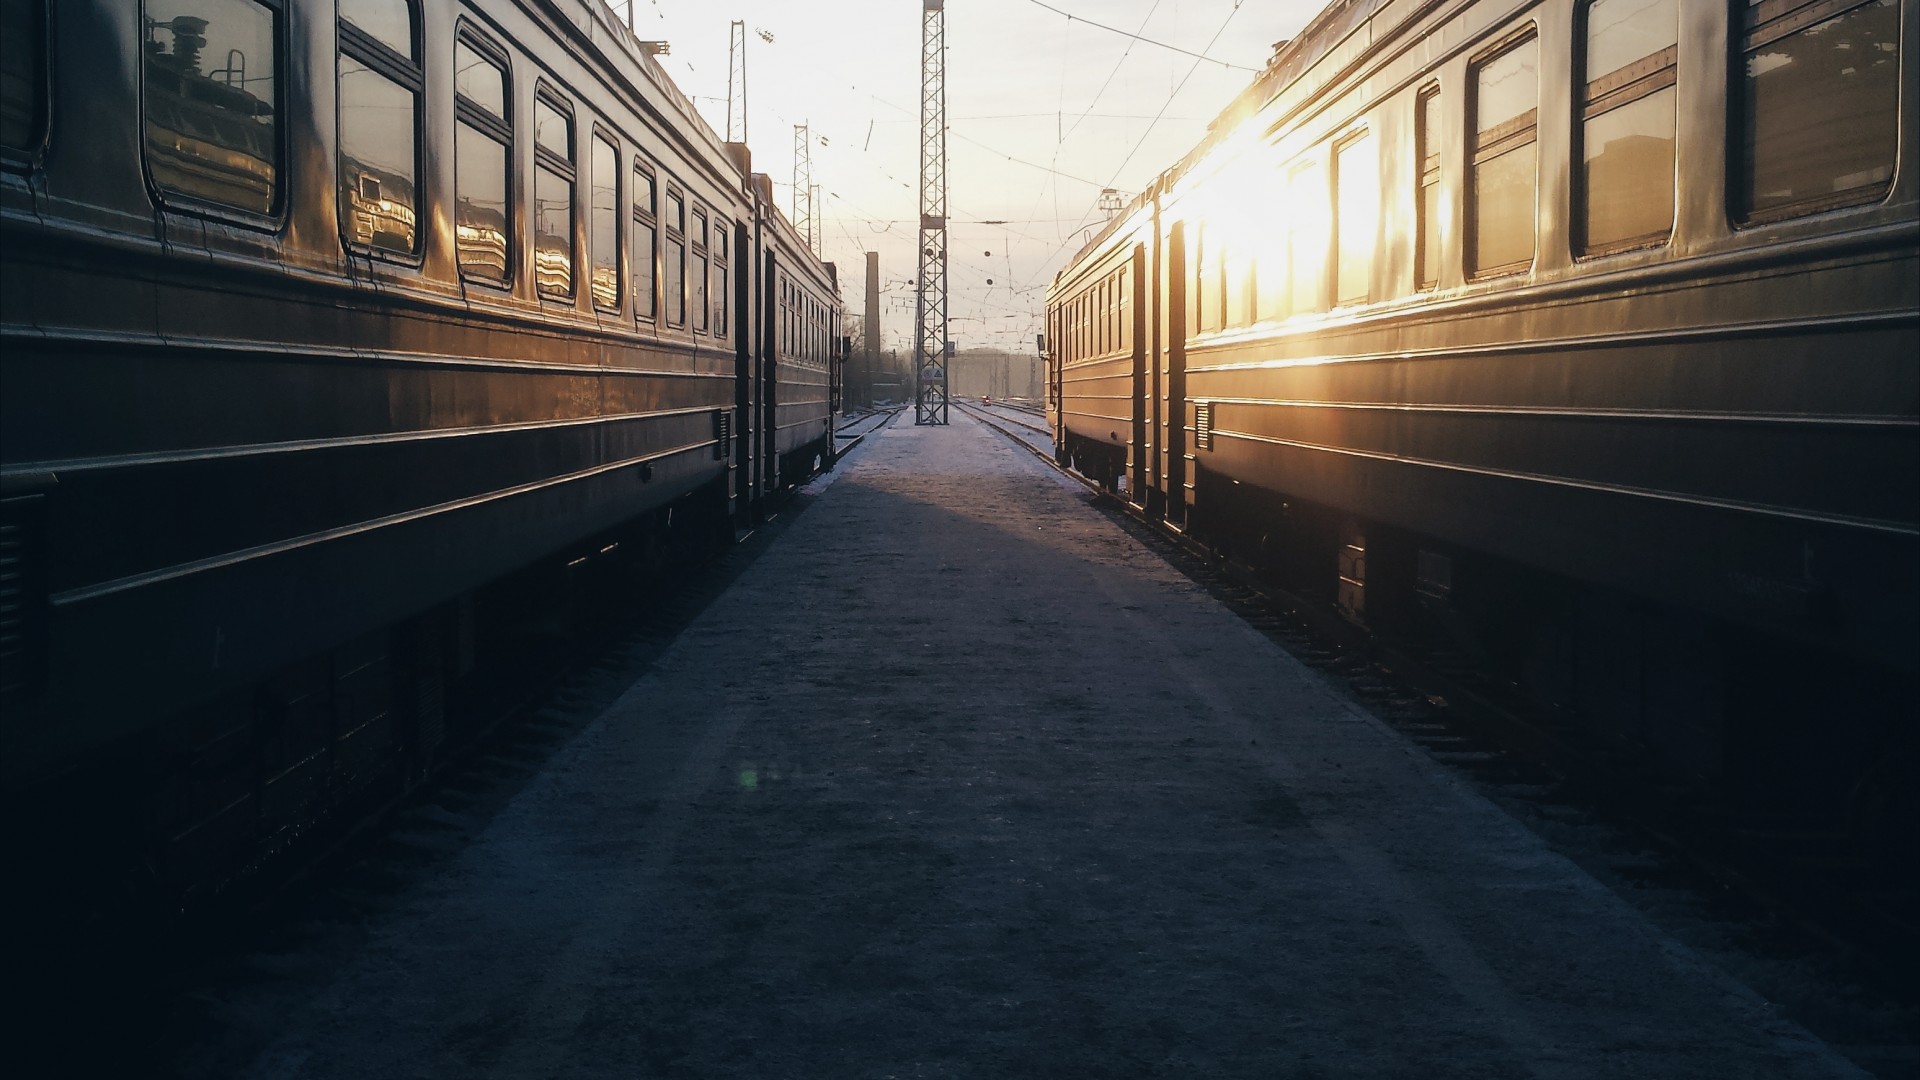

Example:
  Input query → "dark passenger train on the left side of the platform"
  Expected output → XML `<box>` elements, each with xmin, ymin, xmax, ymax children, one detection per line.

<box><xmin>0</xmin><ymin>0</ymin><xmax>841</xmax><ymax>876</ymax></box>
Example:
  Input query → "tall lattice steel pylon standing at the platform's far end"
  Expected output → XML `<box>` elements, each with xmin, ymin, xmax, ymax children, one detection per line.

<box><xmin>914</xmin><ymin>0</ymin><xmax>948</xmax><ymax>425</ymax></box>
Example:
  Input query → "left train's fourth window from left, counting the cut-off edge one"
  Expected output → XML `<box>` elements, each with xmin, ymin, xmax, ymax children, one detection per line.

<box><xmin>453</xmin><ymin>33</ymin><xmax>513</xmax><ymax>284</ymax></box>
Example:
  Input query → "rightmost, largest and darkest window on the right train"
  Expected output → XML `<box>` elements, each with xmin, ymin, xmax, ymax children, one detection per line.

<box><xmin>1728</xmin><ymin>0</ymin><xmax>1901</xmax><ymax>223</ymax></box>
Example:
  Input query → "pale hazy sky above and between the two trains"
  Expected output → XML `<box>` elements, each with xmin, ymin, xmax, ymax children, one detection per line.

<box><xmin>609</xmin><ymin>0</ymin><xmax>1325</xmax><ymax>352</ymax></box>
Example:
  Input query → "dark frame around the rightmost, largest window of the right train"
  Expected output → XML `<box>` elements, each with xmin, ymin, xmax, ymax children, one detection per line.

<box><xmin>1726</xmin><ymin>0</ymin><xmax>1908</xmax><ymax>229</ymax></box>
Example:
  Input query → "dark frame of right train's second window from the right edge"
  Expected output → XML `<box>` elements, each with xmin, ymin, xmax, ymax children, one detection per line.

<box><xmin>1567</xmin><ymin>0</ymin><xmax>1680</xmax><ymax>259</ymax></box>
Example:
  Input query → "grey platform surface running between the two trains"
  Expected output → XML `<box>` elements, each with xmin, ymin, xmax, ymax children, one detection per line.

<box><xmin>224</xmin><ymin>411</ymin><xmax>1859</xmax><ymax>1080</ymax></box>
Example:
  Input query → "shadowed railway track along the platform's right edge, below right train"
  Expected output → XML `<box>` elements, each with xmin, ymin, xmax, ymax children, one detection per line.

<box><xmin>956</xmin><ymin>400</ymin><xmax>1920</xmax><ymax>1007</ymax></box>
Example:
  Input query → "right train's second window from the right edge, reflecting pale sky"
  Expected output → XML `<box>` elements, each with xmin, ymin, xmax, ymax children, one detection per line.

<box><xmin>1574</xmin><ymin>0</ymin><xmax>1680</xmax><ymax>256</ymax></box>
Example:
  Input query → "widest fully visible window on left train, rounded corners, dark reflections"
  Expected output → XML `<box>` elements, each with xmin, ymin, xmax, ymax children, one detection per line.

<box><xmin>142</xmin><ymin>0</ymin><xmax>282</xmax><ymax>213</ymax></box>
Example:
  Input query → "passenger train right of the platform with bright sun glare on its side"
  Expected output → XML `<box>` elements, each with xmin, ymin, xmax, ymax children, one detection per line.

<box><xmin>1048</xmin><ymin>0</ymin><xmax>1920</xmax><ymax>817</ymax></box>
